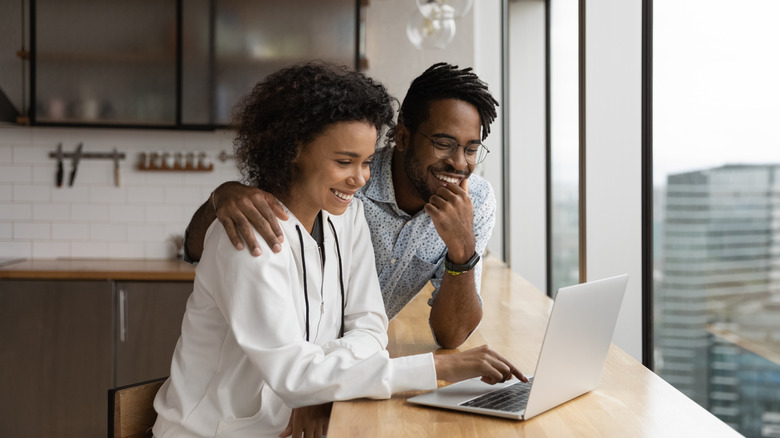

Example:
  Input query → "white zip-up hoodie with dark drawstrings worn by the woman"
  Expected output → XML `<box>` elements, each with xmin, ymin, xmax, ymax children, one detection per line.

<box><xmin>153</xmin><ymin>199</ymin><xmax>436</xmax><ymax>438</ymax></box>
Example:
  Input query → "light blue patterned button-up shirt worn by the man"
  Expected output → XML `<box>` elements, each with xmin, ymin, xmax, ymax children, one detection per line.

<box><xmin>357</xmin><ymin>147</ymin><xmax>496</xmax><ymax>318</ymax></box>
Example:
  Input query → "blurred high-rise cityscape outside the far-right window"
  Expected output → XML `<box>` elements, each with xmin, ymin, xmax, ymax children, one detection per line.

<box><xmin>654</xmin><ymin>165</ymin><xmax>780</xmax><ymax>437</ymax></box>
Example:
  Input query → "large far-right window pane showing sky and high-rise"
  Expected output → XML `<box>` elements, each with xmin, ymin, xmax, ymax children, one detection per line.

<box><xmin>653</xmin><ymin>0</ymin><xmax>780</xmax><ymax>437</ymax></box>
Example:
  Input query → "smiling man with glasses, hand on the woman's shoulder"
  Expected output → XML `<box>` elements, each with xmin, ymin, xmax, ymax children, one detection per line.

<box><xmin>185</xmin><ymin>63</ymin><xmax>498</xmax><ymax>348</ymax></box>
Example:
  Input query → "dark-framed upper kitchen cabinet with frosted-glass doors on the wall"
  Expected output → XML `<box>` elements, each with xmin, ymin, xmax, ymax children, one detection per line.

<box><xmin>31</xmin><ymin>0</ymin><xmax>359</xmax><ymax>129</ymax></box>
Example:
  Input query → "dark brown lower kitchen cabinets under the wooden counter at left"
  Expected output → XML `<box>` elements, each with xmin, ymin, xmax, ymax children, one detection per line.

<box><xmin>0</xmin><ymin>279</ymin><xmax>192</xmax><ymax>437</ymax></box>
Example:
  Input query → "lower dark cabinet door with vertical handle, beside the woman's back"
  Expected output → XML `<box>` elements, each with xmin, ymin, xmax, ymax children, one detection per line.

<box><xmin>116</xmin><ymin>281</ymin><xmax>192</xmax><ymax>386</ymax></box>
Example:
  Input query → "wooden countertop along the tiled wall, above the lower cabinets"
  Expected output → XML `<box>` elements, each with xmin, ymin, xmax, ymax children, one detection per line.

<box><xmin>0</xmin><ymin>259</ymin><xmax>195</xmax><ymax>281</ymax></box>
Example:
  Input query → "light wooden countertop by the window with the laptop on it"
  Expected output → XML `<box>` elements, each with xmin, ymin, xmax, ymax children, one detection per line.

<box><xmin>328</xmin><ymin>258</ymin><xmax>741</xmax><ymax>438</ymax></box>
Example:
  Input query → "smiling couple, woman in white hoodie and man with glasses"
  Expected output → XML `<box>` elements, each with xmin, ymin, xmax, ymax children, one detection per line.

<box><xmin>154</xmin><ymin>63</ymin><xmax>525</xmax><ymax>438</ymax></box>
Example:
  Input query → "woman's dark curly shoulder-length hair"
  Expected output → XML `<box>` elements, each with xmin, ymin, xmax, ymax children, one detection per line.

<box><xmin>234</xmin><ymin>62</ymin><xmax>397</xmax><ymax>197</ymax></box>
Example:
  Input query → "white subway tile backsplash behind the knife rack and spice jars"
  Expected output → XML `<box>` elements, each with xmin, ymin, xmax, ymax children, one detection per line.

<box><xmin>0</xmin><ymin>125</ymin><xmax>238</xmax><ymax>259</ymax></box>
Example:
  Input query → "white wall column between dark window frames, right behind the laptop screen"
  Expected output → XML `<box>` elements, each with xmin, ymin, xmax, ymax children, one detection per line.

<box><xmin>585</xmin><ymin>0</ymin><xmax>642</xmax><ymax>361</ymax></box>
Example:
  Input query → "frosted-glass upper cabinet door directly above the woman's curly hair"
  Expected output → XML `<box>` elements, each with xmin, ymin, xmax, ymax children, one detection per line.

<box><xmin>181</xmin><ymin>0</ymin><xmax>358</xmax><ymax>126</ymax></box>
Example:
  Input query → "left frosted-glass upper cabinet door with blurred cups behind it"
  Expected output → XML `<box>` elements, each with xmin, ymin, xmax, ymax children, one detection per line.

<box><xmin>32</xmin><ymin>0</ymin><xmax>177</xmax><ymax>127</ymax></box>
